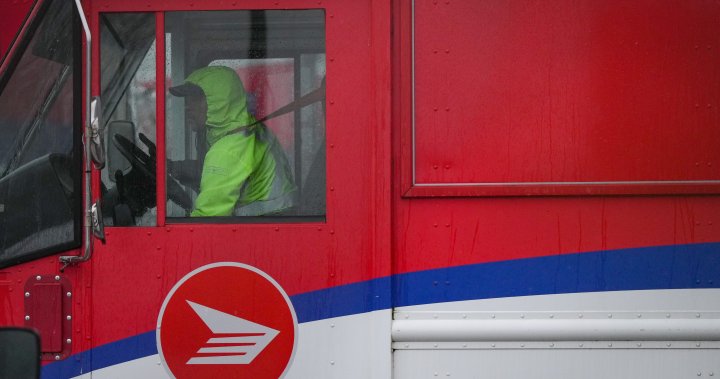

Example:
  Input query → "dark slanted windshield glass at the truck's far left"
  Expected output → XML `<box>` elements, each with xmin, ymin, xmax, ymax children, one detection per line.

<box><xmin>0</xmin><ymin>1</ymin><xmax>82</xmax><ymax>267</ymax></box>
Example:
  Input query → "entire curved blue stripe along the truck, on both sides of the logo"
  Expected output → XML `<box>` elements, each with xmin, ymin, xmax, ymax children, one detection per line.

<box><xmin>42</xmin><ymin>243</ymin><xmax>720</xmax><ymax>379</ymax></box>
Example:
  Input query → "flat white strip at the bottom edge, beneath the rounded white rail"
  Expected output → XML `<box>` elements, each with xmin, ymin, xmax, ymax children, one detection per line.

<box><xmin>393</xmin><ymin>349</ymin><xmax>720</xmax><ymax>379</ymax></box>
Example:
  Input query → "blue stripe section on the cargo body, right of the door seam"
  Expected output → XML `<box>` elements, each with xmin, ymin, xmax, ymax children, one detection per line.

<box><xmin>393</xmin><ymin>243</ymin><xmax>720</xmax><ymax>307</ymax></box>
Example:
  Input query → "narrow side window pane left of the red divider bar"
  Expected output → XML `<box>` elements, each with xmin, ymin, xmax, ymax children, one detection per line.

<box><xmin>100</xmin><ymin>13</ymin><xmax>157</xmax><ymax>226</ymax></box>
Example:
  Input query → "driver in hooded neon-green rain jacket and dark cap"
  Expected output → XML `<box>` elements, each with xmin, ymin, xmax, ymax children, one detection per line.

<box><xmin>168</xmin><ymin>66</ymin><xmax>296</xmax><ymax>217</ymax></box>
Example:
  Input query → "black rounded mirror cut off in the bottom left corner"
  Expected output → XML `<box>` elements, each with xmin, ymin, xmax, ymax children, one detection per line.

<box><xmin>0</xmin><ymin>328</ymin><xmax>40</xmax><ymax>379</ymax></box>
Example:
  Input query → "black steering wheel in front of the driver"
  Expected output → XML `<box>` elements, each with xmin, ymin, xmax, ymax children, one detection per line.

<box><xmin>113</xmin><ymin>133</ymin><xmax>193</xmax><ymax>211</ymax></box>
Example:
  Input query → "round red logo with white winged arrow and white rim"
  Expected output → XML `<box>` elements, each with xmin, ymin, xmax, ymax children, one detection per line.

<box><xmin>157</xmin><ymin>262</ymin><xmax>297</xmax><ymax>379</ymax></box>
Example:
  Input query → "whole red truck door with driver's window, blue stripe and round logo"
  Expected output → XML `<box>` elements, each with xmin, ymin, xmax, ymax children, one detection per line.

<box><xmin>85</xmin><ymin>1</ymin><xmax>391</xmax><ymax>378</ymax></box>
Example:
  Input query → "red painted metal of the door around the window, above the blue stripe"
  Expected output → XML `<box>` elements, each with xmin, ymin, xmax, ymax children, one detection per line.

<box><xmin>79</xmin><ymin>0</ymin><xmax>391</xmax><ymax>346</ymax></box>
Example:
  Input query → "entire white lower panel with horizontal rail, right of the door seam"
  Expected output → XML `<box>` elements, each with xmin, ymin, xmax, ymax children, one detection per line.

<box><xmin>393</xmin><ymin>289</ymin><xmax>720</xmax><ymax>379</ymax></box>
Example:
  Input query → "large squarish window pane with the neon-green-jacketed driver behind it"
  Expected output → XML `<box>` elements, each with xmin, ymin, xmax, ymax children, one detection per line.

<box><xmin>166</xmin><ymin>10</ymin><xmax>326</xmax><ymax>221</ymax></box>
